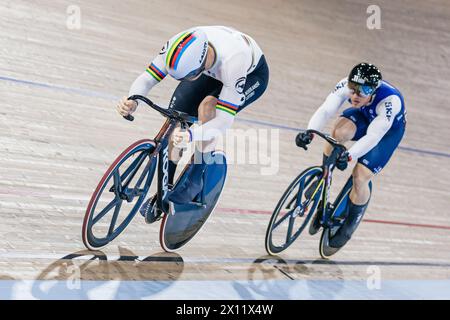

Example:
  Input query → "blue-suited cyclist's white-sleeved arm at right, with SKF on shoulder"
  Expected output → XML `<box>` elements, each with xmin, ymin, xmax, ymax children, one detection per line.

<box><xmin>348</xmin><ymin>95</ymin><xmax>402</xmax><ymax>160</ymax></box>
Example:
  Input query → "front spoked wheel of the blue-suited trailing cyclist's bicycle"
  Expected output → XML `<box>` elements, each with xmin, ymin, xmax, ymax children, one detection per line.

<box><xmin>266</xmin><ymin>167</ymin><xmax>322</xmax><ymax>255</ymax></box>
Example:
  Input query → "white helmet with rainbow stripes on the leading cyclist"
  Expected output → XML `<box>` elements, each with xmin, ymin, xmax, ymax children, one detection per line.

<box><xmin>165</xmin><ymin>29</ymin><xmax>208</xmax><ymax>81</ymax></box>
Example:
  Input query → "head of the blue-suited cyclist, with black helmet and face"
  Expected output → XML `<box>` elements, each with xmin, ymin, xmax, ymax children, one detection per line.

<box><xmin>348</xmin><ymin>62</ymin><xmax>382</xmax><ymax>107</ymax></box>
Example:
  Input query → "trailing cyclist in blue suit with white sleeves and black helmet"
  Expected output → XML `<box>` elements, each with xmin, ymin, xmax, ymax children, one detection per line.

<box><xmin>296</xmin><ymin>63</ymin><xmax>406</xmax><ymax>248</ymax></box>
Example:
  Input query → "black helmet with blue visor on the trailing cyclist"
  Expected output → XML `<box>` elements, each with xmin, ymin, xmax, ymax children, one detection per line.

<box><xmin>348</xmin><ymin>62</ymin><xmax>382</xmax><ymax>95</ymax></box>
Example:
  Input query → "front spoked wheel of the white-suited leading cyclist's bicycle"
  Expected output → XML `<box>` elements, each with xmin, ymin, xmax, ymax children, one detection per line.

<box><xmin>82</xmin><ymin>139</ymin><xmax>157</xmax><ymax>250</ymax></box>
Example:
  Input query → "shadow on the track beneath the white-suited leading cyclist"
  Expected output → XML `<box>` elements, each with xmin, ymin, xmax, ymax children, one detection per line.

<box><xmin>31</xmin><ymin>247</ymin><xmax>184</xmax><ymax>299</ymax></box>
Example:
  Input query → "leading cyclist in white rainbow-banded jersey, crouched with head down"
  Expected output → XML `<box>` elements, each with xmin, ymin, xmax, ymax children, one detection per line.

<box><xmin>117</xmin><ymin>26</ymin><xmax>269</xmax><ymax>221</ymax></box>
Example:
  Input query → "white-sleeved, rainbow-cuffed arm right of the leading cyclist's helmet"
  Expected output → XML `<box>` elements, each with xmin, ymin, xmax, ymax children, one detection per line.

<box><xmin>191</xmin><ymin>55</ymin><xmax>247</xmax><ymax>141</ymax></box>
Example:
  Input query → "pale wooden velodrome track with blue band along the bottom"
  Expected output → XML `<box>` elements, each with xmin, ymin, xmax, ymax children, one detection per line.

<box><xmin>0</xmin><ymin>0</ymin><xmax>450</xmax><ymax>299</ymax></box>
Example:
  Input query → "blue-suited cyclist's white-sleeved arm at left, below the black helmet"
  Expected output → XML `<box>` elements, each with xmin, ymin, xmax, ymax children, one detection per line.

<box><xmin>308</xmin><ymin>78</ymin><xmax>349</xmax><ymax>131</ymax></box>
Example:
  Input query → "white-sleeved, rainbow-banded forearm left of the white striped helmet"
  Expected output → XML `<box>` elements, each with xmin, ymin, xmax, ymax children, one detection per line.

<box><xmin>128</xmin><ymin>54</ymin><xmax>167</xmax><ymax>103</ymax></box>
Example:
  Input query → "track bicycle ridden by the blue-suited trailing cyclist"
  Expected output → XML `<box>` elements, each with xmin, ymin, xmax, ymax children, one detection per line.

<box><xmin>265</xmin><ymin>130</ymin><xmax>372</xmax><ymax>259</ymax></box>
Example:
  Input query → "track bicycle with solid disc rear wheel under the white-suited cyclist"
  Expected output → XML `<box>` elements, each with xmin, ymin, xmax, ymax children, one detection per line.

<box><xmin>82</xmin><ymin>95</ymin><xmax>227</xmax><ymax>252</ymax></box>
